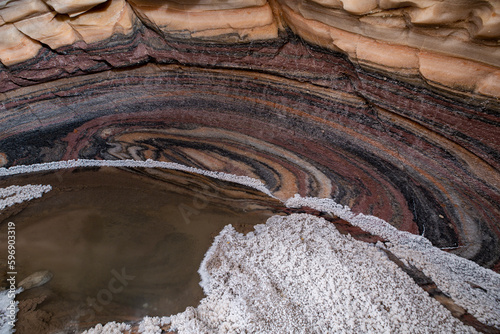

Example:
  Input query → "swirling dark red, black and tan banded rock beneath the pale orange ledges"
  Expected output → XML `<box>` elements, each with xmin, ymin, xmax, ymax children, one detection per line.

<box><xmin>0</xmin><ymin>59</ymin><xmax>500</xmax><ymax>270</ymax></box>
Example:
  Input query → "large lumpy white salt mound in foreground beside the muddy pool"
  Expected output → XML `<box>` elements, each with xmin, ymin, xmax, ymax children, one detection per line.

<box><xmin>171</xmin><ymin>214</ymin><xmax>476</xmax><ymax>333</ymax></box>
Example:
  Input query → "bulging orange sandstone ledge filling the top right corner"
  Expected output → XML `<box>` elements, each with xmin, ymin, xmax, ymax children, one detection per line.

<box><xmin>278</xmin><ymin>0</ymin><xmax>500</xmax><ymax>97</ymax></box>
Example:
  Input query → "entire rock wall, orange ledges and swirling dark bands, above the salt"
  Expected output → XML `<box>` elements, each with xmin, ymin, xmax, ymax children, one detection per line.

<box><xmin>0</xmin><ymin>0</ymin><xmax>500</xmax><ymax>332</ymax></box>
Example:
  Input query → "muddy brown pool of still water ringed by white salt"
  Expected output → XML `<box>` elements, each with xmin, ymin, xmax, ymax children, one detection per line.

<box><xmin>0</xmin><ymin>168</ymin><xmax>286</xmax><ymax>333</ymax></box>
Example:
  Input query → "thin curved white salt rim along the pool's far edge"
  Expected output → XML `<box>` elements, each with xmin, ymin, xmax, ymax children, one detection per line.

<box><xmin>0</xmin><ymin>159</ymin><xmax>275</xmax><ymax>198</ymax></box>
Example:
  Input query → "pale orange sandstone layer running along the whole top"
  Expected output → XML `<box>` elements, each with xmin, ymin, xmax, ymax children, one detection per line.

<box><xmin>0</xmin><ymin>0</ymin><xmax>500</xmax><ymax>100</ymax></box>
